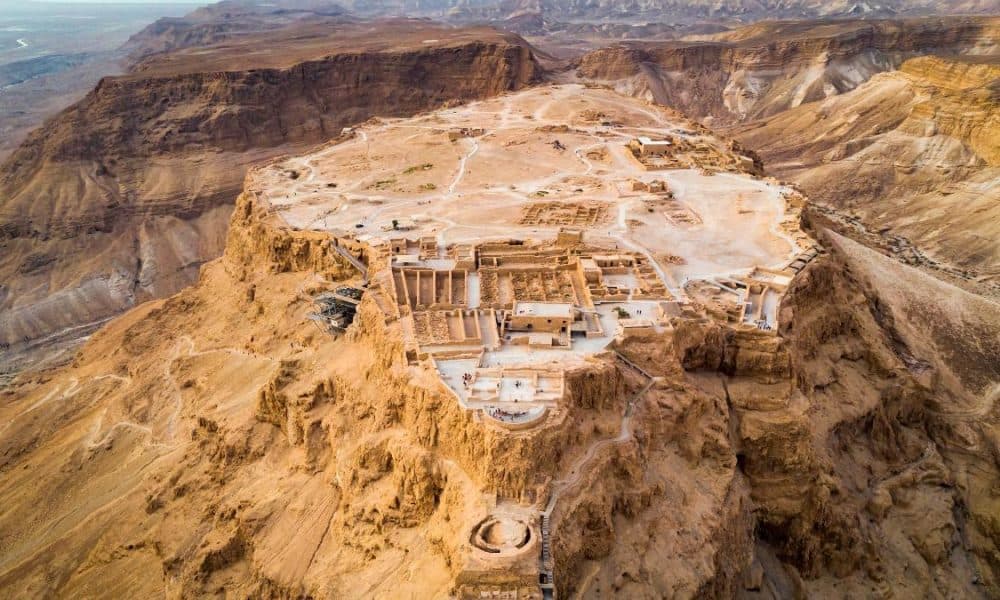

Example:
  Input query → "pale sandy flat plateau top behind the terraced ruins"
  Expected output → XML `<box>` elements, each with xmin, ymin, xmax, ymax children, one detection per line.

<box><xmin>259</xmin><ymin>85</ymin><xmax>798</xmax><ymax>293</ymax></box>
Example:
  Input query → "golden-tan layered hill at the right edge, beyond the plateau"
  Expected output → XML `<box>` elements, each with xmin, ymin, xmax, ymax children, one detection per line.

<box><xmin>734</xmin><ymin>56</ymin><xmax>1000</xmax><ymax>295</ymax></box>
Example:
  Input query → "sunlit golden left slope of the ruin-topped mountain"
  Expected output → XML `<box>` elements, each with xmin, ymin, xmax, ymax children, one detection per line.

<box><xmin>0</xmin><ymin>162</ymin><xmax>627</xmax><ymax>598</ymax></box>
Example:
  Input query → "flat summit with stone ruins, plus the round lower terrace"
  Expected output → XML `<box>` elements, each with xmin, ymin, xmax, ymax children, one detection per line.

<box><xmin>251</xmin><ymin>86</ymin><xmax>819</xmax><ymax>598</ymax></box>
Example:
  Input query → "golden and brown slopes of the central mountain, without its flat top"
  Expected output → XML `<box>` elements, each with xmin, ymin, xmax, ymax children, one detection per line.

<box><xmin>0</xmin><ymin>90</ymin><xmax>1000</xmax><ymax>599</ymax></box>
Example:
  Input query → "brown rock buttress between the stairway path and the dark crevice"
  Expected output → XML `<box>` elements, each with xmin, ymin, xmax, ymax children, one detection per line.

<box><xmin>553</xmin><ymin>372</ymin><xmax>755</xmax><ymax>598</ymax></box>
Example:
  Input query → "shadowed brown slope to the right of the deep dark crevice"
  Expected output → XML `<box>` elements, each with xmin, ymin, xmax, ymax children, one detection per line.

<box><xmin>727</xmin><ymin>231</ymin><xmax>1000</xmax><ymax>596</ymax></box>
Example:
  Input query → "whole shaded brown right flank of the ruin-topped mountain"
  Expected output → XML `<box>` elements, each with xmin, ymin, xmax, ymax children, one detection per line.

<box><xmin>568</xmin><ymin>233</ymin><xmax>1000</xmax><ymax>597</ymax></box>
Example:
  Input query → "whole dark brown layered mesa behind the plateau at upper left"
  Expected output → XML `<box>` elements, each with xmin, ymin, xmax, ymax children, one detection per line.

<box><xmin>0</xmin><ymin>21</ymin><xmax>537</xmax><ymax>364</ymax></box>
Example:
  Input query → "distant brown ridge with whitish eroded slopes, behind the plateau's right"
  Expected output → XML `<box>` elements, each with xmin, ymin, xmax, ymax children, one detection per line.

<box><xmin>577</xmin><ymin>17</ymin><xmax>1000</xmax><ymax>127</ymax></box>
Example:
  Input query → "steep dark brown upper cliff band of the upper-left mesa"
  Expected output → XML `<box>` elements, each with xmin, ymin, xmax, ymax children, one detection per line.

<box><xmin>2</xmin><ymin>42</ymin><xmax>535</xmax><ymax>191</ymax></box>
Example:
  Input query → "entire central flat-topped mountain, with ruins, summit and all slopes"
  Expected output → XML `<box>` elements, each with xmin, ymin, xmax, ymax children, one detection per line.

<box><xmin>0</xmin><ymin>86</ymin><xmax>1000</xmax><ymax>598</ymax></box>
